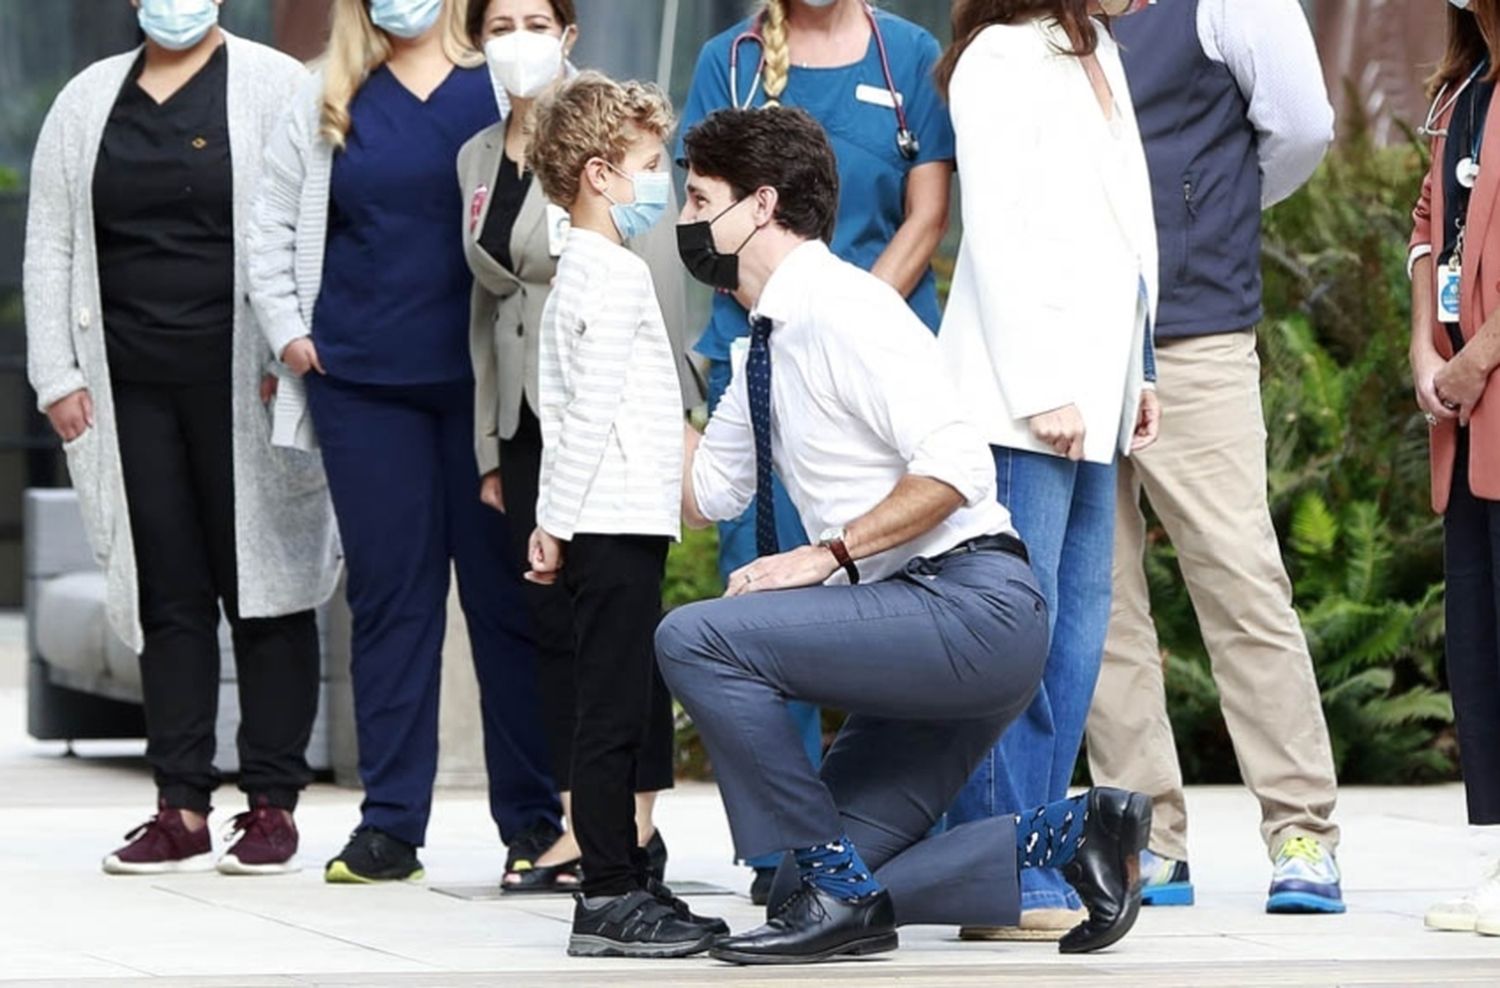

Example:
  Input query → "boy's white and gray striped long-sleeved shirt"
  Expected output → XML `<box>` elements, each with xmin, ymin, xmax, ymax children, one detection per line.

<box><xmin>537</xmin><ymin>226</ymin><xmax>683</xmax><ymax>540</ymax></box>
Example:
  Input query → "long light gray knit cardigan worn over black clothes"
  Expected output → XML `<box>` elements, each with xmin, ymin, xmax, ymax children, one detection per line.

<box><xmin>24</xmin><ymin>33</ymin><xmax>339</xmax><ymax>652</ymax></box>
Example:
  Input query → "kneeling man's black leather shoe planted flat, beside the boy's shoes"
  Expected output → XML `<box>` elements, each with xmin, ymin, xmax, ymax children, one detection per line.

<box><xmin>708</xmin><ymin>885</ymin><xmax>900</xmax><ymax>964</ymax></box>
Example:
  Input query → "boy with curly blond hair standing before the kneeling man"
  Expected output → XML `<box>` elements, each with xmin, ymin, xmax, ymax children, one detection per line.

<box><xmin>527</xmin><ymin>72</ymin><xmax>725</xmax><ymax>957</ymax></box>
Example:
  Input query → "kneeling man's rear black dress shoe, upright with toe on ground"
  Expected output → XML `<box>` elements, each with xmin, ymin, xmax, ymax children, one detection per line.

<box><xmin>1058</xmin><ymin>789</ymin><xmax>1151</xmax><ymax>954</ymax></box>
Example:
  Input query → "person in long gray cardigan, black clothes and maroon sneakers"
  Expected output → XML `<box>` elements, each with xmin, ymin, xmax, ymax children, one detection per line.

<box><xmin>26</xmin><ymin>0</ymin><xmax>338</xmax><ymax>874</ymax></box>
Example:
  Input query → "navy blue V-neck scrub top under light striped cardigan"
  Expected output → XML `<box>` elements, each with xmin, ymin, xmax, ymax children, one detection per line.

<box><xmin>312</xmin><ymin>66</ymin><xmax>500</xmax><ymax>384</ymax></box>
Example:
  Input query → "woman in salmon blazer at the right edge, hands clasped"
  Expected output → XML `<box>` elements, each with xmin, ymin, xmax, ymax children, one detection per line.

<box><xmin>1410</xmin><ymin>0</ymin><xmax>1500</xmax><ymax>936</ymax></box>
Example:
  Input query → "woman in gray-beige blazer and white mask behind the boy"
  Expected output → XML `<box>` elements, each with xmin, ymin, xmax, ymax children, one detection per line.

<box><xmin>459</xmin><ymin>0</ymin><xmax>704</xmax><ymax>892</ymax></box>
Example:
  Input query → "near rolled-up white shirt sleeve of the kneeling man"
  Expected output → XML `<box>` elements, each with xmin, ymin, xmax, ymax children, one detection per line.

<box><xmin>821</xmin><ymin>291</ymin><xmax>995</xmax><ymax>507</ymax></box>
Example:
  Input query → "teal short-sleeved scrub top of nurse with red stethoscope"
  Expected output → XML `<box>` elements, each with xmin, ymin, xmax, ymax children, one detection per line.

<box><xmin>677</xmin><ymin>9</ymin><xmax>956</xmax><ymax>360</ymax></box>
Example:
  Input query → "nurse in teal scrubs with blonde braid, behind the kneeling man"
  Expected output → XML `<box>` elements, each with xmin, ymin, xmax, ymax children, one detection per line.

<box><xmin>678</xmin><ymin>0</ymin><xmax>954</xmax><ymax>903</ymax></box>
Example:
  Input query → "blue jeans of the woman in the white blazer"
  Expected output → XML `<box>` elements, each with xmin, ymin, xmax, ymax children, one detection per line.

<box><xmin>948</xmin><ymin>447</ymin><xmax>1115</xmax><ymax>909</ymax></box>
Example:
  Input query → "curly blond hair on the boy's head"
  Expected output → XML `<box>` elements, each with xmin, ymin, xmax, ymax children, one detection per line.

<box><xmin>527</xmin><ymin>72</ymin><xmax>677</xmax><ymax>208</ymax></box>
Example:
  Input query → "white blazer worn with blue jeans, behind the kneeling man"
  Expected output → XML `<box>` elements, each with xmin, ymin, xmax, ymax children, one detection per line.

<box><xmin>938</xmin><ymin>18</ymin><xmax>1157</xmax><ymax>463</ymax></box>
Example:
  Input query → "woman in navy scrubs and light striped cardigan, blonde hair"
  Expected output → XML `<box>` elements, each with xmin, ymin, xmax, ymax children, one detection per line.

<box><xmin>252</xmin><ymin>0</ymin><xmax>560</xmax><ymax>882</ymax></box>
